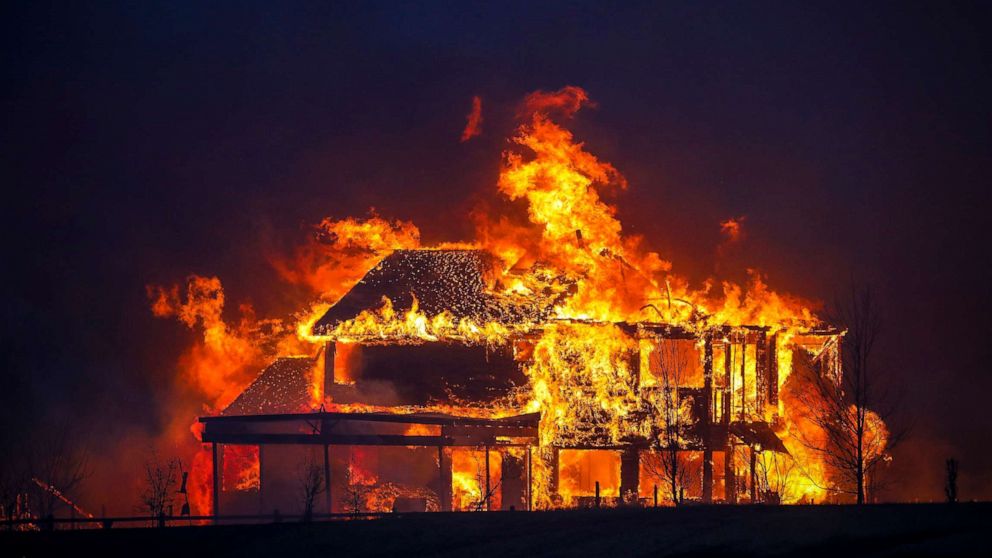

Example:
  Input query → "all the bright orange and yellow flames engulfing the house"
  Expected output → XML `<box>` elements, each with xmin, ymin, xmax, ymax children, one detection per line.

<box><xmin>155</xmin><ymin>86</ymin><xmax>885</xmax><ymax>509</ymax></box>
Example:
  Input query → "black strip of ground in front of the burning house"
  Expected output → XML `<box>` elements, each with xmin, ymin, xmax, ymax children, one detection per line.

<box><xmin>0</xmin><ymin>504</ymin><xmax>992</xmax><ymax>558</ymax></box>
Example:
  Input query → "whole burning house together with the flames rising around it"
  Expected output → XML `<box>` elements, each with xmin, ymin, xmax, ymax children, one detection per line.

<box><xmin>150</xmin><ymin>87</ymin><xmax>884</xmax><ymax>513</ymax></box>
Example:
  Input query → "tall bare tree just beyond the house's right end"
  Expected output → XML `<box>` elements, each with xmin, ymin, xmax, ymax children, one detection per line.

<box><xmin>798</xmin><ymin>283</ymin><xmax>901</xmax><ymax>504</ymax></box>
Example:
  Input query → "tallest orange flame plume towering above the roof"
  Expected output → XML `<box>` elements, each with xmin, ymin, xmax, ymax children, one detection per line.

<box><xmin>487</xmin><ymin>87</ymin><xmax>671</xmax><ymax>321</ymax></box>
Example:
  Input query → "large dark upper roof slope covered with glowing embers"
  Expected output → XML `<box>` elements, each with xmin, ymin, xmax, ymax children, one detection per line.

<box><xmin>313</xmin><ymin>250</ymin><xmax>547</xmax><ymax>334</ymax></box>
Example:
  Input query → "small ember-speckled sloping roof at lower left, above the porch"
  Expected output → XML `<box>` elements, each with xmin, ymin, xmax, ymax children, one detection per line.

<box><xmin>220</xmin><ymin>357</ymin><xmax>314</xmax><ymax>416</ymax></box>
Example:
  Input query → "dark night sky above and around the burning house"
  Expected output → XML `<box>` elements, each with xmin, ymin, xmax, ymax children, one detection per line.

<box><xmin>0</xmin><ymin>2</ymin><xmax>992</xmax><ymax>499</ymax></box>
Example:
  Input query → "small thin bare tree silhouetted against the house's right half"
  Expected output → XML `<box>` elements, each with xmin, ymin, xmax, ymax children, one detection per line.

<box><xmin>645</xmin><ymin>339</ymin><xmax>696</xmax><ymax>505</ymax></box>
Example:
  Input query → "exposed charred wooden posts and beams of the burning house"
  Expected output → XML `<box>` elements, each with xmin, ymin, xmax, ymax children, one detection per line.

<box><xmin>205</xmin><ymin>323</ymin><xmax>843</xmax><ymax>514</ymax></box>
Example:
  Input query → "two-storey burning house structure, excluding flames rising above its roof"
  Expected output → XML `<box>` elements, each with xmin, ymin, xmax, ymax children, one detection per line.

<box><xmin>200</xmin><ymin>249</ymin><xmax>839</xmax><ymax>512</ymax></box>
